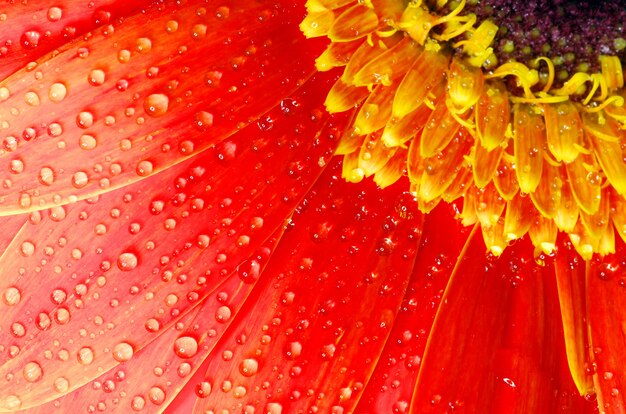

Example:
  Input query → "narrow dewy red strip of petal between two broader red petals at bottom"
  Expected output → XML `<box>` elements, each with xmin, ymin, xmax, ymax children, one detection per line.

<box><xmin>356</xmin><ymin>204</ymin><xmax>469</xmax><ymax>414</ymax></box>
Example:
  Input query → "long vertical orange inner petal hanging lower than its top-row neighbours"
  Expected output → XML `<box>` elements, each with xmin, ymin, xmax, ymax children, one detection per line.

<box><xmin>513</xmin><ymin>104</ymin><xmax>546</xmax><ymax>194</ymax></box>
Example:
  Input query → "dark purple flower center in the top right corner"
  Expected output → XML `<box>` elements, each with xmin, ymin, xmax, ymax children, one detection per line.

<box><xmin>449</xmin><ymin>0</ymin><xmax>626</xmax><ymax>78</ymax></box>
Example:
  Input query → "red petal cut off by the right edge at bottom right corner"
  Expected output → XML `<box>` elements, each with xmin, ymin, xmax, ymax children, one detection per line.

<box><xmin>587</xmin><ymin>238</ymin><xmax>626</xmax><ymax>413</ymax></box>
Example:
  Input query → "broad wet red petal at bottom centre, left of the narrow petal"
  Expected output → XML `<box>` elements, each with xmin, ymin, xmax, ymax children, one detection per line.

<box><xmin>173</xmin><ymin>164</ymin><xmax>422</xmax><ymax>413</ymax></box>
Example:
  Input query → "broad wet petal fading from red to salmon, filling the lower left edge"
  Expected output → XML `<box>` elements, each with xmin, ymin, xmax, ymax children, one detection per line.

<box><xmin>0</xmin><ymin>76</ymin><xmax>346</xmax><ymax>408</ymax></box>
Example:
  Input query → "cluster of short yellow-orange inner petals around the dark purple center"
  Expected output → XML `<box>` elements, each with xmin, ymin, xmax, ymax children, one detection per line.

<box><xmin>300</xmin><ymin>0</ymin><xmax>626</xmax><ymax>259</ymax></box>
